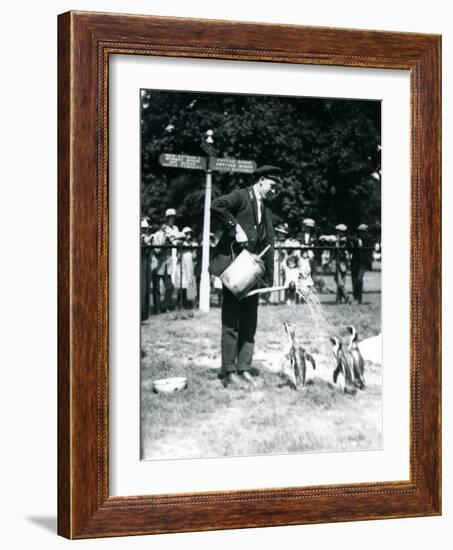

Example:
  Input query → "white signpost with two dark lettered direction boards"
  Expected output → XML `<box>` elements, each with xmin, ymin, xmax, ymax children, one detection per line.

<box><xmin>159</xmin><ymin>144</ymin><xmax>256</xmax><ymax>312</ymax></box>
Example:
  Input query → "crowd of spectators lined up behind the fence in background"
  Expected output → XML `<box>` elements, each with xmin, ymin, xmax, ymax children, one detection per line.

<box><xmin>141</xmin><ymin>208</ymin><xmax>381</xmax><ymax>320</ymax></box>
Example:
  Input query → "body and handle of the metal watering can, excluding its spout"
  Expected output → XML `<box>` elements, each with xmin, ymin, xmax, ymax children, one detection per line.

<box><xmin>220</xmin><ymin>245</ymin><xmax>270</xmax><ymax>300</ymax></box>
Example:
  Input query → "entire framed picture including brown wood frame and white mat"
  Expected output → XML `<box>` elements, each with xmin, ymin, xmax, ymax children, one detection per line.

<box><xmin>58</xmin><ymin>12</ymin><xmax>441</xmax><ymax>539</ymax></box>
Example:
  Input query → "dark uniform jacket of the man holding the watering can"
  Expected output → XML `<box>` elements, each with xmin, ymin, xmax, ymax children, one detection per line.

<box><xmin>209</xmin><ymin>187</ymin><xmax>274</xmax><ymax>286</ymax></box>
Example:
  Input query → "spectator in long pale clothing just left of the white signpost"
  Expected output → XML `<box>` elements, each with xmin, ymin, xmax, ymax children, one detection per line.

<box><xmin>175</xmin><ymin>227</ymin><xmax>197</xmax><ymax>309</ymax></box>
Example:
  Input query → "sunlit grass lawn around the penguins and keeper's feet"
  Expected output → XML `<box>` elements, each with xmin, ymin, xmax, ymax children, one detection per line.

<box><xmin>141</xmin><ymin>293</ymin><xmax>382</xmax><ymax>459</ymax></box>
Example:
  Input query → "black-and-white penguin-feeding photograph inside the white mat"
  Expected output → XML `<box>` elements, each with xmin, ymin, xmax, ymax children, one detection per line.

<box><xmin>137</xmin><ymin>89</ymin><xmax>383</xmax><ymax>460</ymax></box>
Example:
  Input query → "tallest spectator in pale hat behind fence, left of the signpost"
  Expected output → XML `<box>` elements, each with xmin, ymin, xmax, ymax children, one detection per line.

<box><xmin>153</xmin><ymin>208</ymin><xmax>183</xmax><ymax>314</ymax></box>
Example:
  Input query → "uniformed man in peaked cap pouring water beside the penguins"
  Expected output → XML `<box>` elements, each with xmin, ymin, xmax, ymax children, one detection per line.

<box><xmin>210</xmin><ymin>165</ymin><xmax>281</xmax><ymax>387</ymax></box>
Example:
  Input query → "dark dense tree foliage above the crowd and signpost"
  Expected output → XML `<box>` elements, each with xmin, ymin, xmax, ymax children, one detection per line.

<box><xmin>141</xmin><ymin>90</ymin><xmax>381</xmax><ymax>238</ymax></box>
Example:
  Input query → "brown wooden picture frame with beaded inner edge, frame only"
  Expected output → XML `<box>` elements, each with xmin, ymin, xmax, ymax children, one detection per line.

<box><xmin>58</xmin><ymin>12</ymin><xmax>441</xmax><ymax>539</ymax></box>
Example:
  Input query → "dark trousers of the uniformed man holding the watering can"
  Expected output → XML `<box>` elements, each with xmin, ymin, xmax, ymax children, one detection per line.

<box><xmin>222</xmin><ymin>287</ymin><xmax>259</xmax><ymax>374</ymax></box>
